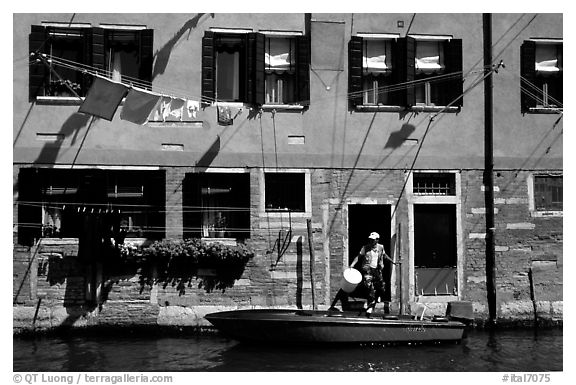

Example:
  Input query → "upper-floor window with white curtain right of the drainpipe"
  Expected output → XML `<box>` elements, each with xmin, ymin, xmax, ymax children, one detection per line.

<box><xmin>520</xmin><ymin>39</ymin><xmax>563</xmax><ymax>112</ymax></box>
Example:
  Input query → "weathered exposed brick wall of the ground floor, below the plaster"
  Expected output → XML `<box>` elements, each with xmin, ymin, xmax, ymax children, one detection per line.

<box><xmin>13</xmin><ymin>168</ymin><xmax>563</xmax><ymax>328</ymax></box>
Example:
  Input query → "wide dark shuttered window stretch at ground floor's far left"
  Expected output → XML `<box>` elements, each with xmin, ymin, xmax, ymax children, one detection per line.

<box><xmin>19</xmin><ymin>169</ymin><xmax>165</xmax><ymax>244</ymax></box>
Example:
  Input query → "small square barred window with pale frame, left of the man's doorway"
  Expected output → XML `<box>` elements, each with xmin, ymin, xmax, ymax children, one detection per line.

<box><xmin>264</xmin><ymin>173</ymin><xmax>306</xmax><ymax>212</ymax></box>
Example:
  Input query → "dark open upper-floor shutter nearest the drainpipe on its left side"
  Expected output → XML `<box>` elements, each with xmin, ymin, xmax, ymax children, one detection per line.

<box><xmin>441</xmin><ymin>39</ymin><xmax>464</xmax><ymax>107</ymax></box>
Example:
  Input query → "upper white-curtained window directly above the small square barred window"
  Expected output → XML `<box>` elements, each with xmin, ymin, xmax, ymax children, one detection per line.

<box><xmin>264</xmin><ymin>37</ymin><xmax>296</xmax><ymax>104</ymax></box>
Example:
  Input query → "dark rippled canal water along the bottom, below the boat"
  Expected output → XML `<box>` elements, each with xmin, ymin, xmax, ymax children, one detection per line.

<box><xmin>13</xmin><ymin>329</ymin><xmax>563</xmax><ymax>372</ymax></box>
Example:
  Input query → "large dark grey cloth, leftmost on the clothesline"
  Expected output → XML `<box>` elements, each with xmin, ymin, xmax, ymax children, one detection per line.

<box><xmin>78</xmin><ymin>76</ymin><xmax>128</xmax><ymax>121</ymax></box>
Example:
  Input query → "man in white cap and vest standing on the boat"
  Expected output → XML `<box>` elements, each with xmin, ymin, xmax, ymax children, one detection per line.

<box><xmin>350</xmin><ymin>232</ymin><xmax>395</xmax><ymax>316</ymax></box>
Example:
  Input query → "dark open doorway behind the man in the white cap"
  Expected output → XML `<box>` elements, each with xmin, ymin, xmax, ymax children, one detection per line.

<box><xmin>348</xmin><ymin>204</ymin><xmax>392</xmax><ymax>301</ymax></box>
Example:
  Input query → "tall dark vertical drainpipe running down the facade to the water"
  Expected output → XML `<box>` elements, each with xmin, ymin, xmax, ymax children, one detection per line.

<box><xmin>482</xmin><ymin>13</ymin><xmax>496</xmax><ymax>325</ymax></box>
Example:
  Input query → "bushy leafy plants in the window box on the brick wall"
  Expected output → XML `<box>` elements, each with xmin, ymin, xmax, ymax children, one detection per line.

<box><xmin>120</xmin><ymin>238</ymin><xmax>254</xmax><ymax>294</ymax></box>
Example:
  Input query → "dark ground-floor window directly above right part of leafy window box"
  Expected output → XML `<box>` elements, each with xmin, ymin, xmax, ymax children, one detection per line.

<box><xmin>183</xmin><ymin>173</ymin><xmax>250</xmax><ymax>239</ymax></box>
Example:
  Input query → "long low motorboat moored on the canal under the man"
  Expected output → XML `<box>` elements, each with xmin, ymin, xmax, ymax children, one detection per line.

<box><xmin>205</xmin><ymin>309</ymin><xmax>466</xmax><ymax>344</ymax></box>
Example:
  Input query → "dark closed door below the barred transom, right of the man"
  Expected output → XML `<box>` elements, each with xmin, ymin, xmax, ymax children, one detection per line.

<box><xmin>414</xmin><ymin>204</ymin><xmax>457</xmax><ymax>295</ymax></box>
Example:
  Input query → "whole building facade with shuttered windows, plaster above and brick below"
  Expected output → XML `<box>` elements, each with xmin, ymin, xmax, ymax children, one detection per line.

<box><xmin>13</xmin><ymin>13</ymin><xmax>563</xmax><ymax>329</ymax></box>
